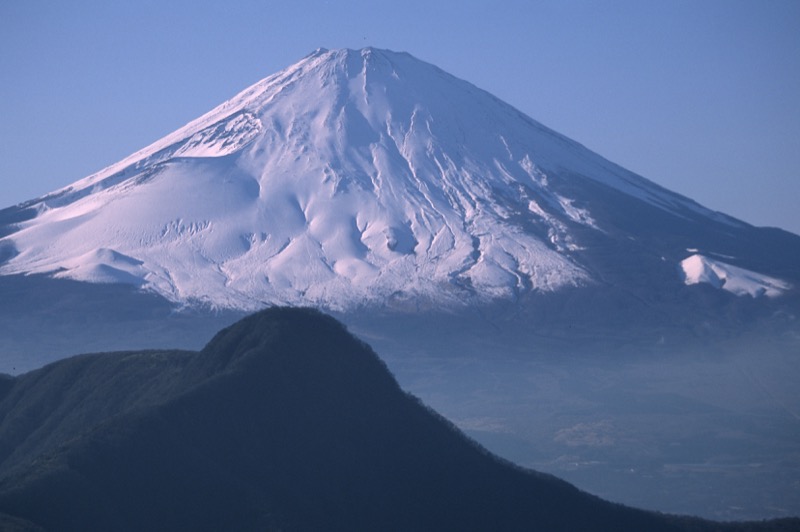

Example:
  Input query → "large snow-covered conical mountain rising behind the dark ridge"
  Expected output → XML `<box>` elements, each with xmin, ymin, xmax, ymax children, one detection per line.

<box><xmin>0</xmin><ymin>48</ymin><xmax>800</xmax><ymax>309</ymax></box>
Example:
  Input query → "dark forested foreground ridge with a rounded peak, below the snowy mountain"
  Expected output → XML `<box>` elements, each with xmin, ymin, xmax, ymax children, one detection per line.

<box><xmin>0</xmin><ymin>308</ymin><xmax>800</xmax><ymax>531</ymax></box>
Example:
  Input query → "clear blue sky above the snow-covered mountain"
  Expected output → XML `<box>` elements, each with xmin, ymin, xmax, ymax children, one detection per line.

<box><xmin>0</xmin><ymin>0</ymin><xmax>800</xmax><ymax>234</ymax></box>
